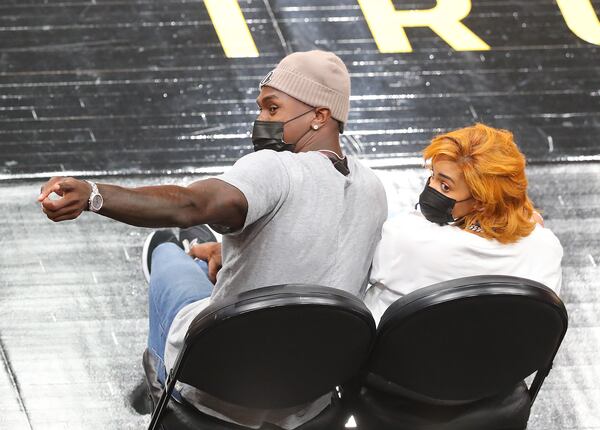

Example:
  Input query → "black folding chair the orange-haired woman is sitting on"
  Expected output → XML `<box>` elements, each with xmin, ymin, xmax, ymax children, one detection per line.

<box><xmin>352</xmin><ymin>276</ymin><xmax>568</xmax><ymax>430</ymax></box>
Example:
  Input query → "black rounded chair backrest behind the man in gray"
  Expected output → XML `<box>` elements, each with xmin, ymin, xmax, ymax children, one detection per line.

<box><xmin>177</xmin><ymin>284</ymin><xmax>375</xmax><ymax>409</ymax></box>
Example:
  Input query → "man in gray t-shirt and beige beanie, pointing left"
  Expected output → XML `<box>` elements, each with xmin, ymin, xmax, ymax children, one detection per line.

<box><xmin>39</xmin><ymin>51</ymin><xmax>387</xmax><ymax>429</ymax></box>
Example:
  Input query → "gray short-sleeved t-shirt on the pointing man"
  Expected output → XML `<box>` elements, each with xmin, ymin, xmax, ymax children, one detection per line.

<box><xmin>165</xmin><ymin>150</ymin><xmax>387</xmax><ymax>429</ymax></box>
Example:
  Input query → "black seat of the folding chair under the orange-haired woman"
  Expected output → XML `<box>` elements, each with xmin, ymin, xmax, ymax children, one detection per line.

<box><xmin>353</xmin><ymin>382</ymin><xmax>531</xmax><ymax>430</ymax></box>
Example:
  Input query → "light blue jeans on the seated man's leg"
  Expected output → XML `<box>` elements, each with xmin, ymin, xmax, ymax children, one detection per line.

<box><xmin>148</xmin><ymin>242</ymin><xmax>213</xmax><ymax>385</ymax></box>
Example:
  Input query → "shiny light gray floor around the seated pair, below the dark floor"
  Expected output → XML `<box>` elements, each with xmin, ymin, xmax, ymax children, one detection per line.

<box><xmin>0</xmin><ymin>164</ymin><xmax>600</xmax><ymax>430</ymax></box>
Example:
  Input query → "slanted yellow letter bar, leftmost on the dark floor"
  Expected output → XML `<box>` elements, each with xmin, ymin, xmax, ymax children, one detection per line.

<box><xmin>204</xmin><ymin>0</ymin><xmax>258</xmax><ymax>58</ymax></box>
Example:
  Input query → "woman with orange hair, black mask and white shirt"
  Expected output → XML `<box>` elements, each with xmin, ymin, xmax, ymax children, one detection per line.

<box><xmin>365</xmin><ymin>124</ymin><xmax>563</xmax><ymax>320</ymax></box>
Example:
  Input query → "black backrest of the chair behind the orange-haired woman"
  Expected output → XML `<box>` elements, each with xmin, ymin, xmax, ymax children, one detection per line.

<box><xmin>367</xmin><ymin>276</ymin><xmax>568</xmax><ymax>403</ymax></box>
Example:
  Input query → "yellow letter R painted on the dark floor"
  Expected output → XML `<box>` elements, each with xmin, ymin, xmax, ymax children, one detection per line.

<box><xmin>358</xmin><ymin>0</ymin><xmax>488</xmax><ymax>53</ymax></box>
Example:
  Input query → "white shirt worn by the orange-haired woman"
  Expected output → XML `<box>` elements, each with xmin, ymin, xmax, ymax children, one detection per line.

<box><xmin>365</xmin><ymin>211</ymin><xmax>563</xmax><ymax>322</ymax></box>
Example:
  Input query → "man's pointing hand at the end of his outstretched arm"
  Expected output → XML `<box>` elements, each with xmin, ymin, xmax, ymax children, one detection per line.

<box><xmin>37</xmin><ymin>176</ymin><xmax>92</xmax><ymax>222</ymax></box>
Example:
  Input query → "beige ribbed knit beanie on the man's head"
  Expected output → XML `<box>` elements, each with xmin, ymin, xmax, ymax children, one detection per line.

<box><xmin>260</xmin><ymin>51</ymin><xmax>350</xmax><ymax>124</ymax></box>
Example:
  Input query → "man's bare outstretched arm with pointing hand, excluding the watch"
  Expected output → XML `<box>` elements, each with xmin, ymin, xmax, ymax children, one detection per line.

<box><xmin>38</xmin><ymin>177</ymin><xmax>248</xmax><ymax>231</ymax></box>
